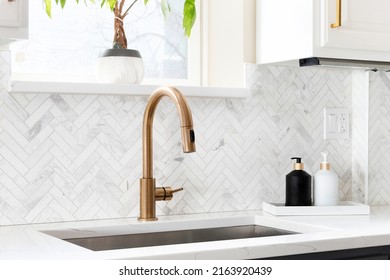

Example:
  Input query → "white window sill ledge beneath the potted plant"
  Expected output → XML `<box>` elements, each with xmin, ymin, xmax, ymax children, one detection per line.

<box><xmin>9</xmin><ymin>81</ymin><xmax>251</xmax><ymax>98</ymax></box>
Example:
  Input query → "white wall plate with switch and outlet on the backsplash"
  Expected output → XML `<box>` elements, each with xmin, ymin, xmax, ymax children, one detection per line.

<box><xmin>324</xmin><ymin>108</ymin><xmax>349</xmax><ymax>139</ymax></box>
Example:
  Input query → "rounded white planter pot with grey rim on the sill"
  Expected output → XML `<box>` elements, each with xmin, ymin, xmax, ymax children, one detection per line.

<box><xmin>95</xmin><ymin>49</ymin><xmax>144</xmax><ymax>84</ymax></box>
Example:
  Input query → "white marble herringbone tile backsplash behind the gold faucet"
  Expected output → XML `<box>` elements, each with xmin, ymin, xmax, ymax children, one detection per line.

<box><xmin>0</xmin><ymin>51</ymin><xmax>384</xmax><ymax>225</ymax></box>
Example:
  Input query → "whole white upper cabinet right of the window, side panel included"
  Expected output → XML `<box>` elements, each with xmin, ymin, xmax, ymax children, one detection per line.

<box><xmin>256</xmin><ymin>0</ymin><xmax>390</xmax><ymax>63</ymax></box>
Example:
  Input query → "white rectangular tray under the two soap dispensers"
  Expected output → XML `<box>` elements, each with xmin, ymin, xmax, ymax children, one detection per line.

<box><xmin>263</xmin><ymin>201</ymin><xmax>370</xmax><ymax>216</ymax></box>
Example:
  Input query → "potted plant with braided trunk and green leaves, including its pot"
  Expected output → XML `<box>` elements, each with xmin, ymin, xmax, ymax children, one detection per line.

<box><xmin>43</xmin><ymin>0</ymin><xmax>196</xmax><ymax>83</ymax></box>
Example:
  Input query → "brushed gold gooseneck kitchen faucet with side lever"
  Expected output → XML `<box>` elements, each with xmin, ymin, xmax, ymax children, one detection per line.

<box><xmin>138</xmin><ymin>87</ymin><xmax>195</xmax><ymax>221</ymax></box>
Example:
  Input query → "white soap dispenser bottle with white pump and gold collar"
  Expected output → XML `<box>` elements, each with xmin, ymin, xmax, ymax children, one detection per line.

<box><xmin>313</xmin><ymin>152</ymin><xmax>338</xmax><ymax>206</ymax></box>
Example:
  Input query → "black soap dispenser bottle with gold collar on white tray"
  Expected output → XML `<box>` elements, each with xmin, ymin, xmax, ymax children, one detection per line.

<box><xmin>286</xmin><ymin>157</ymin><xmax>312</xmax><ymax>206</ymax></box>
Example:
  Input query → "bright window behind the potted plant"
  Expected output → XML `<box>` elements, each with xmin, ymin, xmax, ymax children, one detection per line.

<box><xmin>11</xmin><ymin>0</ymin><xmax>200</xmax><ymax>84</ymax></box>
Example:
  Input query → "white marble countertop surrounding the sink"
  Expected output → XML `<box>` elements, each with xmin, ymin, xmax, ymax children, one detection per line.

<box><xmin>0</xmin><ymin>206</ymin><xmax>390</xmax><ymax>259</ymax></box>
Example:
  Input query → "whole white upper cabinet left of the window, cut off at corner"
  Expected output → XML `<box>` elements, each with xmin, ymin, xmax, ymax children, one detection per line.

<box><xmin>0</xmin><ymin>0</ymin><xmax>28</xmax><ymax>42</ymax></box>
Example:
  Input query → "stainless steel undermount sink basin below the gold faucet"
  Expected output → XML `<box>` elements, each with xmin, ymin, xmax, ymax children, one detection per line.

<box><xmin>44</xmin><ymin>224</ymin><xmax>297</xmax><ymax>251</ymax></box>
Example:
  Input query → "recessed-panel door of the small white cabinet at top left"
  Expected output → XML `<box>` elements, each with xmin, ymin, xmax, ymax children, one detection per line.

<box><xmin>0</xmin><ymin>0</ymin><xmax>22</xmax><ymax>27</ymax></box>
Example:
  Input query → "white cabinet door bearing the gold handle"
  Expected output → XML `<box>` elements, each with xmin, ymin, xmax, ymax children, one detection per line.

<box><xmin>321</xmin><ymin>0</ymin><xmax>390</xmax><ymax>52</ymax></box>
